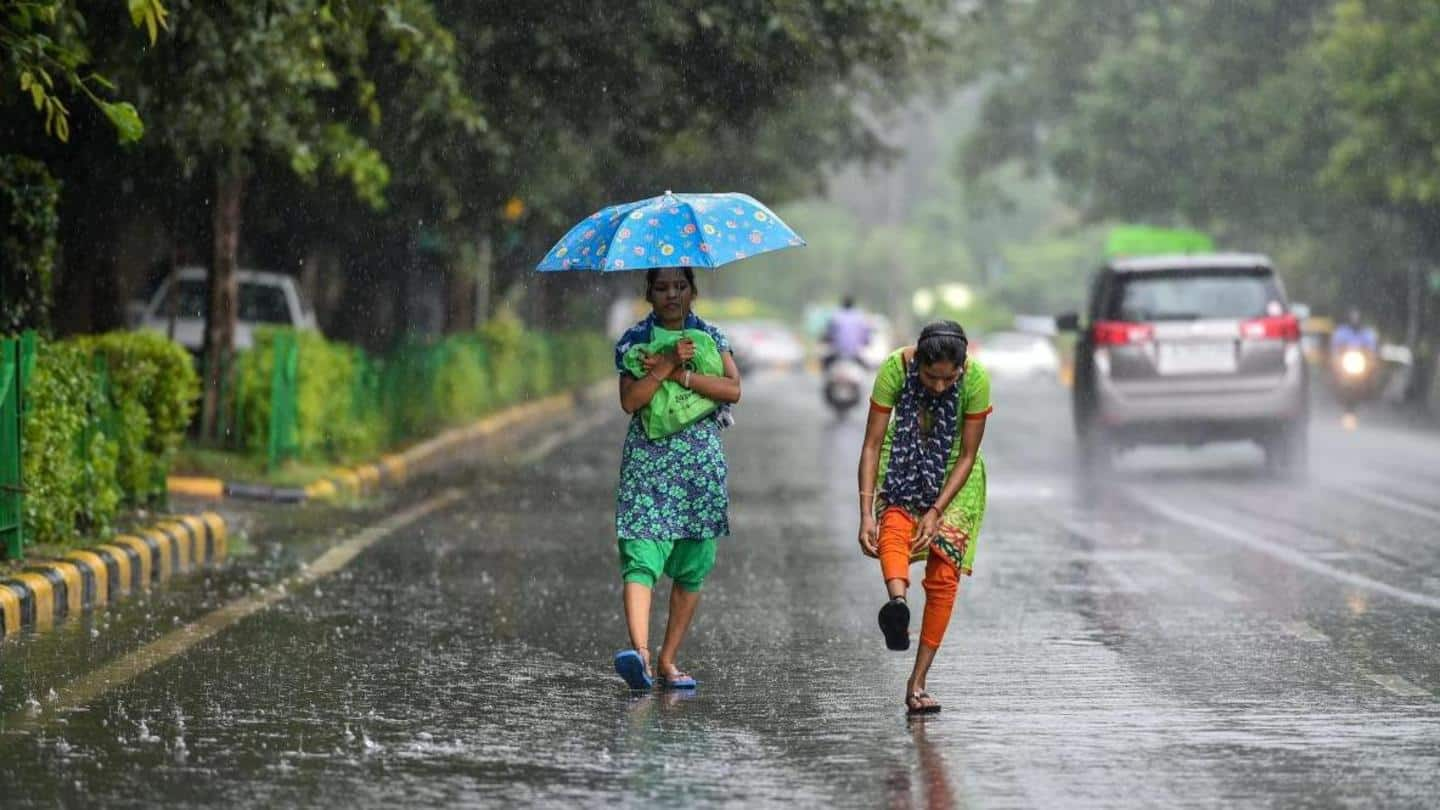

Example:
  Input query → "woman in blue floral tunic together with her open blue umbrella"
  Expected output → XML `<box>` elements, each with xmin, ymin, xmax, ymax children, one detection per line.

<box><xmin>537</xmin><ymin>192</ymin><xmax>805</xmax><ymax>689</ymax></box>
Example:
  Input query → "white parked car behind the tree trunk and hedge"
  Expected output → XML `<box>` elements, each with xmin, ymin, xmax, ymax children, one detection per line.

<box><xmin>138</xmin><ymin>267</ymin><xmax>317</xmax><ymax>353</ymax></box>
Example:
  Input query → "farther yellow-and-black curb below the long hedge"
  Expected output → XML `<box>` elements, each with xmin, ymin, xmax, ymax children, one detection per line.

<box><xmin>168</xmin><ymin>392</ymin><xmax>583</xmax><ymax>503</ymax></box>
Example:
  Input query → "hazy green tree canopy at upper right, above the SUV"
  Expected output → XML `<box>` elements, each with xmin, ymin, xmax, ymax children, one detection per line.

<box><xmin>962</xmin><ymin>0</ymin><xmax>1440</xmax><ymax>336</ymax></box>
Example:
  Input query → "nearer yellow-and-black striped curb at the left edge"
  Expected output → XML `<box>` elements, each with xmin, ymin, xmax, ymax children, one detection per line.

<box><xmin>0</xmin><ymin>512</ymin><xmax>229</xmax><ymax>637</ymax></box>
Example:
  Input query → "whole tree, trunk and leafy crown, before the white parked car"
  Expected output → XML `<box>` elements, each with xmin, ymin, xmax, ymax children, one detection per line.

<box><xmin>124</xmin><ymin>0</ymin><xmax>484</xmax><ymax>437</ymax></box>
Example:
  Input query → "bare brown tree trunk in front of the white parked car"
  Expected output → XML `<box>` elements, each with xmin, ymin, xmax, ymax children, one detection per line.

<box><xmin>200</xmin><ymin>161</ymin><xmax>245</xmax><ymax>440</ymax></box>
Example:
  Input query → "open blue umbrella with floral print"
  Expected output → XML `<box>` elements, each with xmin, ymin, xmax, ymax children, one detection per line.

<box><xmin>536</xmin><ymin>192</ymin><xmax>805</xmax><ymax>272</ymax></box>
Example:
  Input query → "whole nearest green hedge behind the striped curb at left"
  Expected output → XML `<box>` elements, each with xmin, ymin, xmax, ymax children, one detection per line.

<box><xmin>22</xmin><ymin>331</ymin><xmax>199</xmax><ymax>543</ymax></box>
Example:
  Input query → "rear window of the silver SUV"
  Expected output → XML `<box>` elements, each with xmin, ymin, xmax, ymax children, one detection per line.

<box><xmin>1110</xmin><ymin>271</ymin><xmax>1280</xmax><ymax>321</ymax></box>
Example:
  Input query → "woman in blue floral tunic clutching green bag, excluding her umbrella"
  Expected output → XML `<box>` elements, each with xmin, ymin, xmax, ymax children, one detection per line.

<box><xmin>615</xmin><ymin>268</ymin><xmax>740</xmax><ymax>689</ymax></box>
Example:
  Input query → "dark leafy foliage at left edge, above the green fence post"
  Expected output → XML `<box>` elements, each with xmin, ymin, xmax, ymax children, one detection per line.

<box><xmin>0</xmin><ymin>154</ymin><xmax>60</xmax><ymax>333</ymax></box>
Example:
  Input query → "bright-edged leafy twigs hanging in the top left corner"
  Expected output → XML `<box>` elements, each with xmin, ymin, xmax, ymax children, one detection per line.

<box><xmin>0</xmin><ymin>0</ymin><xmax>168</xmax><ymax>143</ymax></box>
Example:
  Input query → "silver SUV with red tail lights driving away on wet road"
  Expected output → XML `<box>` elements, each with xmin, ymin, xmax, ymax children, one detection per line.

<box><xmin>1057</xmin><ymin>254</ymin><xmax>1309</xmax><ymax>473</ymax></box>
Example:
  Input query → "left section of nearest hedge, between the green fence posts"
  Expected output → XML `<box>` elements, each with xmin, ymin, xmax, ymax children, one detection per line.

<box><xmin>23</xmin><ymin>342</ymin><xmax>121</xmax><ymax>543</ymax></box>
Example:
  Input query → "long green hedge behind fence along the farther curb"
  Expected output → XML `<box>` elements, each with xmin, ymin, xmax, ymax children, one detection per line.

<box><xmin>233</xmin><ymin>317</ymin><xmax>611</xmax><ymax>463</ymax></box>
